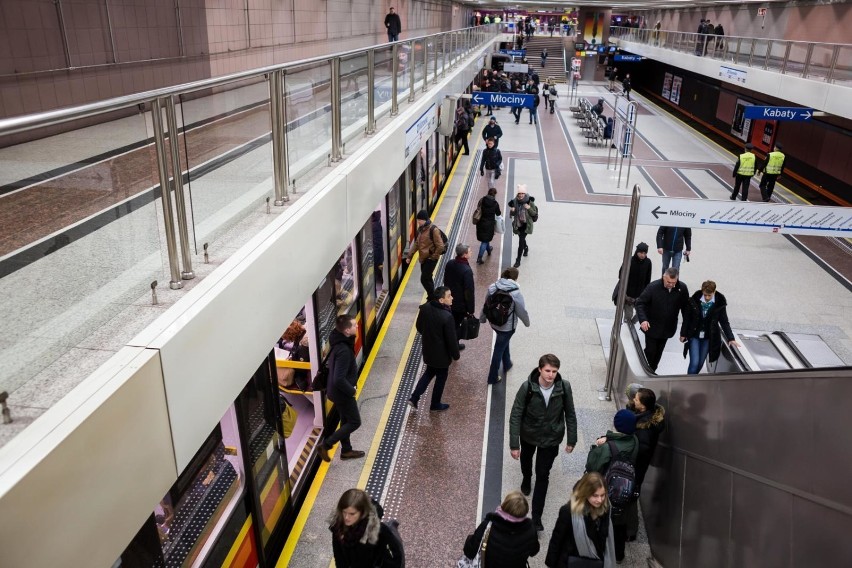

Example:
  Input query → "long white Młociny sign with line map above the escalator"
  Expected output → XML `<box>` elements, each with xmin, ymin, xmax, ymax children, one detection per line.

<box><xmin>636</xmin><ymin>196</ymin><xmax>852</xmax><ymax>237</ymax></box>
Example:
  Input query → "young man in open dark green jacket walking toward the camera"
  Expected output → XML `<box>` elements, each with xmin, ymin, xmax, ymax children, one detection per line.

<box><xmin>509</xmin><ymin>354</ymin><xmax>577</xmax><ymax>531</ymax></box>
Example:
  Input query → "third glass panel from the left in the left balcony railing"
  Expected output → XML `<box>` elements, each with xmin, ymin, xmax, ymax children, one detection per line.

<box><xmin>284</xmin><ymin>62</ymin><xmax>331</xmax><ymax>181</ymax></box>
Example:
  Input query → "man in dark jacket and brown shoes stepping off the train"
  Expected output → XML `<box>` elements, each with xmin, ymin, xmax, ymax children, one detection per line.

<box><xmin>318</xmin><ymin>315</ymin><xmax>364</xmax><ymax>461</ymax></box>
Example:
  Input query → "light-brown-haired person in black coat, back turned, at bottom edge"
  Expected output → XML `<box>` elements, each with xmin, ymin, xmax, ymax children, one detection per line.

<box><xmin>464</xmin><ymin>491</ymin><xmax>541</xmax><ymax>568</ymax></box>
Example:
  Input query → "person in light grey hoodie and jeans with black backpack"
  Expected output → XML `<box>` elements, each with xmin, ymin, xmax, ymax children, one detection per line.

<box><xmin>479</xmin><ymin>267</ymin><xmax>530</xmax><ymax>385</ymax></box>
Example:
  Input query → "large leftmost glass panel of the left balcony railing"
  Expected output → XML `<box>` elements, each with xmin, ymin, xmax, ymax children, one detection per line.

<box><xmin>0</xmin><ymin>106</ymin><xmax>169</xmax><ymax>400</ymax></box>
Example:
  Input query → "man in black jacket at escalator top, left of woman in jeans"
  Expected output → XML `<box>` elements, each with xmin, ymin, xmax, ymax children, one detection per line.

<box><xmin>636</xmin><ymin>268</ymin><xmax>689</xmax><ymax>372</ymax></box>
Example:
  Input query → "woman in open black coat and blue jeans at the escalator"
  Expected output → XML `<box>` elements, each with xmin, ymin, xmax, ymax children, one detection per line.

<box><xmin>680</xmin><ymin>280</ymin><xmax>739</xmax><ymax>375</ymax></box>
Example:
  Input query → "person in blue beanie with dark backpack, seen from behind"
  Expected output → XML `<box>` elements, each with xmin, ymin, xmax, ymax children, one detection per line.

<box><xmin>586</xmin><ymin>408</ymin><xmax>639</xmax><ymax>562</ymax></box>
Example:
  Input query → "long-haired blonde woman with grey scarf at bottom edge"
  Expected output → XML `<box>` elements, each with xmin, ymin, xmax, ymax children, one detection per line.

<box><xmin>544</xmin><ymin>472</ymin><xmax>615</xmax><ymax>568</ymax></box>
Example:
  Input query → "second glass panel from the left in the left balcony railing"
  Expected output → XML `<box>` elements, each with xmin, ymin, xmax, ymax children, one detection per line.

<box><xmin>178</xmin><ymin>76</ymin><xmax>275</xmax><ymax>250</ymax></box>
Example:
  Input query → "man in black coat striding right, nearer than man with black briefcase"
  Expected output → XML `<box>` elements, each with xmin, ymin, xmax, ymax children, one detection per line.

<box><xmin>408</xmin><ymin>286</ymin><xmax>460</xmax><ymax>411</ymax></box>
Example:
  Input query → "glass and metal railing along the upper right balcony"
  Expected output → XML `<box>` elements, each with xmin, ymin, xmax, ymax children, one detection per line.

<box><xmin>610</xmin><ymin>27</ymin><xmax>852</xmax><ymax>85</ymax></box>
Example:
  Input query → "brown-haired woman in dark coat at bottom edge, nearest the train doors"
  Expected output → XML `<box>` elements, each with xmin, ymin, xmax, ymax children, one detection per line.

<box><xmin>328</xmin><ymin>489</ymin><xmax>405</xmax><ymax>568</ymax></box>
